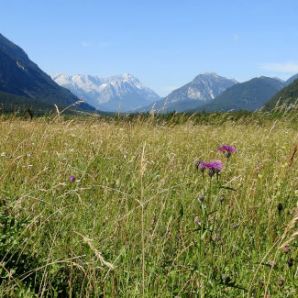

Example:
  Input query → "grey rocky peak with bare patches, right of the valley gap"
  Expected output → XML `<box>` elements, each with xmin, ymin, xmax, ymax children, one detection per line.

<box><xmin>139</xmin><ymin>73</ymin><xmax>237</xmax><ymax>112</ymax></box>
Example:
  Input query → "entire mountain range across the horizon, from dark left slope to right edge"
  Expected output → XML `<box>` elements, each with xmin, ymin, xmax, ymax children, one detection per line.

<box><xmin>0</xmin><ymin>34</ymin><xmax>298</xmax><ymax>113</ymax></box>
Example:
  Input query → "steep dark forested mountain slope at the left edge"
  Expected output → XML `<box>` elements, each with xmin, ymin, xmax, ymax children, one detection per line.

<box><xmin>0</xmin><ymin>34</ymin><xmax>95</xmax><ymax>111</ymax></box>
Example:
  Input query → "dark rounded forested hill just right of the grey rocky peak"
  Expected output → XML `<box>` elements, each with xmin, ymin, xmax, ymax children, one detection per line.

<box><xmin>197</xmin><ymin>77</ymin><xmax>285</xmax><ymax>112</ymax></box>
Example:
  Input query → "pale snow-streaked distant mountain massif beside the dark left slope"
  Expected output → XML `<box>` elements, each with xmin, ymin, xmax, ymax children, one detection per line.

<box><xmin>53</xmin><ymin>74</ymin><xmax>160</xmax><ymax>112</ymax></box>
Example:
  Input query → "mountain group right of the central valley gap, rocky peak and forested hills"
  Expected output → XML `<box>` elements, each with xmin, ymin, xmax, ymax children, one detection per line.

<box><xmin>137</xmin><ymin>73</ymin><xmax>298</xmax><ymax>113</ymax></box>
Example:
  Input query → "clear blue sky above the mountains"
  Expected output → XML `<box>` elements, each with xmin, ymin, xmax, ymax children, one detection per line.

<box><xmin>0</xmin><ymin>0</ymin><xmax>298</xmax><ymax>95</ymax></box>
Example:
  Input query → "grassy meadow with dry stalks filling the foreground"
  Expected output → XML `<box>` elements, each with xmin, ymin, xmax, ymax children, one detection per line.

<box><xmin>0</xmin><ymin>116</ymin><xmax>298</xmax><ymax>298</ymax></box>
